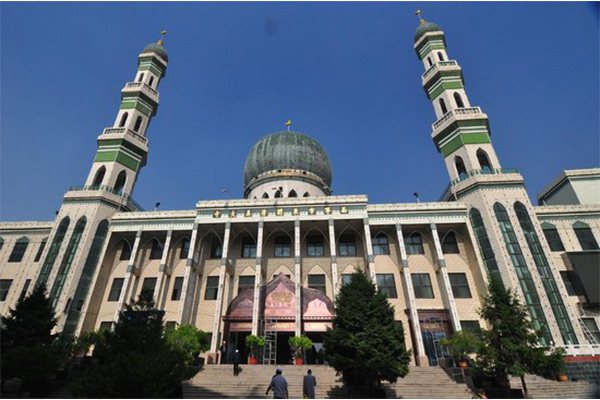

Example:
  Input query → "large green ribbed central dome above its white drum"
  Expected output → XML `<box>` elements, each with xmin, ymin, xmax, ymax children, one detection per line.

<box><xmin>244</xmin><ymin>132</ymin><xmax>331</xmax><ymax>186</ymax></box>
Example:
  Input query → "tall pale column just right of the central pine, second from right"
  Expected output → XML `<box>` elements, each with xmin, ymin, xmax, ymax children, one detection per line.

<box><xmin>396</xmin><ymin>224</ymin><xmax>429</xmax><ymax>366</ymax></box>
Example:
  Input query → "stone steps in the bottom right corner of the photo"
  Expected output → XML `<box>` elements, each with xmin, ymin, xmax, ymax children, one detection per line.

<box><xmin>510</xmin><ymin>375</ymin><xmax>600</xmax><ymax>399</ymax></box>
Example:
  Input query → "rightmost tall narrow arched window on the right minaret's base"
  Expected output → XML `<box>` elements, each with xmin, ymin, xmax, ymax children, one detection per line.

<box><xmin>515</xmin><ymin>201</ymin><xmax>578</xmax><ymax>344</ymax></box>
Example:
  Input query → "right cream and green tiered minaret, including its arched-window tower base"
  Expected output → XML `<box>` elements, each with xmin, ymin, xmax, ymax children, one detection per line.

<box><xmin>414</xmin><ymin>11</ymin><xmax>584</xmax><ymax>345</ymax></box>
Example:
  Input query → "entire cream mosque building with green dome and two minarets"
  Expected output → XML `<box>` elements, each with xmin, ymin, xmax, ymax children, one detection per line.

<box><xmin>0</xmin><ymin>19</ymin><xmax>600</xmax><ymax>366</ymax></box>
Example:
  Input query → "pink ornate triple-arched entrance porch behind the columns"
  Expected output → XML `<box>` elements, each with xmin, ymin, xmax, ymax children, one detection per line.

<box><xmin>224</xmin><ymin>273</ymin><xmax>334</xmax><ymax>365</ymax></box>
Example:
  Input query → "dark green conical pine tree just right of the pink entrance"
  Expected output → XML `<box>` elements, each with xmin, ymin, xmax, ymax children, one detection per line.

<box><xmin>324</xmin><ymin>271</ymin><xmax>410</xmax><ymax>391</ymax></box>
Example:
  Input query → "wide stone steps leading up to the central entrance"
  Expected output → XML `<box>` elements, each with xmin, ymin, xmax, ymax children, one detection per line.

<box><xmin>183</xmin><ymin>365</ymin><xmax>472</xmax><ymax>399</ymax></box>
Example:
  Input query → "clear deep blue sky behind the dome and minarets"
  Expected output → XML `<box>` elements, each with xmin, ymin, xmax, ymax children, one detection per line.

<box><xmin>0</xmin><ymin>2</ymin><xmax>600</xmax><ymax>221</ymax></box>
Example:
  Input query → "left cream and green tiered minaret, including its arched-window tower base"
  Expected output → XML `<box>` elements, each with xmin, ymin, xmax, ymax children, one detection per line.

<box><xmin>36</xmin><ymin>35</ymin><xmax>168</xmax><ymax>334</ymax></box>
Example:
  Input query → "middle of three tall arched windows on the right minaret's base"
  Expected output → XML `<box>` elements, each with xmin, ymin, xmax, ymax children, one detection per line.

<box><xmin>494</xmin><ymin>203</ymin><xmax>552</xmax><ymax>346</ymax></box>
